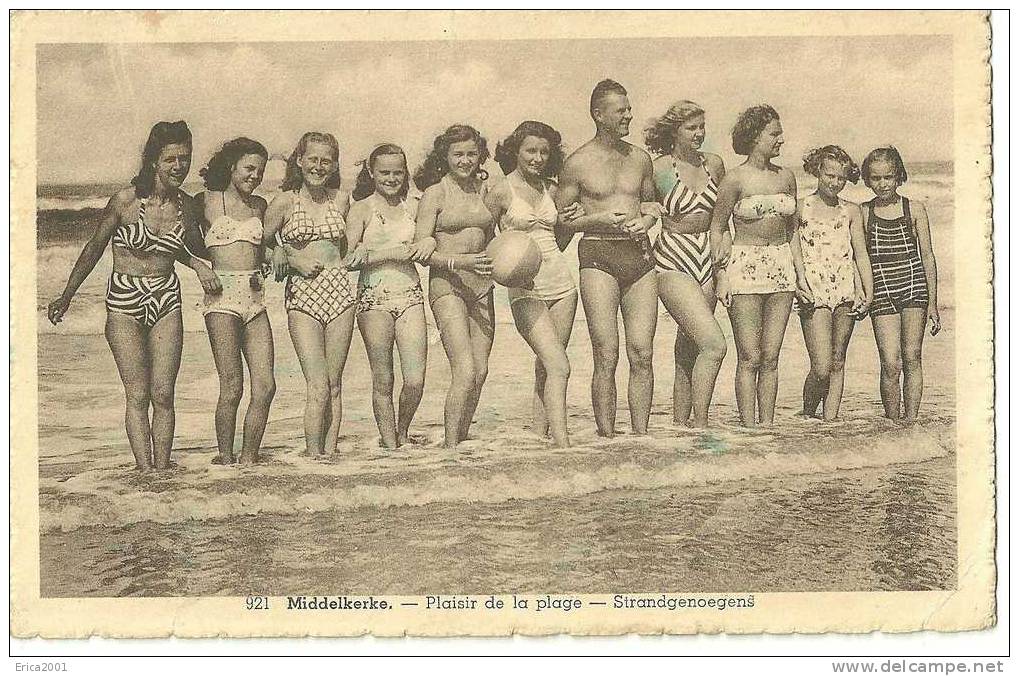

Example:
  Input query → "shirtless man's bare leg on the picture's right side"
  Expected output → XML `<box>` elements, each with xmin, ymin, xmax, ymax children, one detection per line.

<box><xmin>620</xmin><ymin>271</ymin><xmax>658</xmax><ymax>434</ymax></box>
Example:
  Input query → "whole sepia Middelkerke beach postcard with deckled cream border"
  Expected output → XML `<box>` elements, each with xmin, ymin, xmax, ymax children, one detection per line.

<box><xmin>10</xmin><ymin>11</ymin><xmax>996</xmax><ymax>637</ymax></box>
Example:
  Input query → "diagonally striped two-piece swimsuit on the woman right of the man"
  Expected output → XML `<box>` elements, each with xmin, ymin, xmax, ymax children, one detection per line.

<box><xmin>654</xmin><ymin>163</ymin><xmax>718</xmax><ymax>284</ymax></box>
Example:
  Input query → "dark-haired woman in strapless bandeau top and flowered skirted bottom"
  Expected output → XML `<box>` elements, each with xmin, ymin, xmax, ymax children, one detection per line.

<box><xmin>711</xmin><ymin>105</ymin><xmax>803</xmax><ymax>427</ymax></box>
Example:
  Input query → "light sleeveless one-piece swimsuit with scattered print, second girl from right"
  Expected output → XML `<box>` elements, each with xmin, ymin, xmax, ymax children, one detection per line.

<box><xmin>797</xmin><ymin>199</ymin><xmax>856</xmax><ymax>311</ymax></box>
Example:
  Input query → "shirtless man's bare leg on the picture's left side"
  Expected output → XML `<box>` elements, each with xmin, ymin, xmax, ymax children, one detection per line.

<box><xmin>580</xmin><ymin>268</ymin><xmax>620</xmax><ymax>436</ymax></box>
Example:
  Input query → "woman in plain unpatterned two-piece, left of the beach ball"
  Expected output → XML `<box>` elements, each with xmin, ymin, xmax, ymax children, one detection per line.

<box><xmin>413</xmin><ymin>124</ymin><xmax>495</xmax><ymax>448</ymax></box>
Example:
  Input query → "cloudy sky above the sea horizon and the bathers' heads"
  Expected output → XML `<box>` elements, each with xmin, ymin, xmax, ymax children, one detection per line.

<box><xmin>37</xmin><ymin>36</ymin><xmax>953</xmax><ymax>184</ymax></box>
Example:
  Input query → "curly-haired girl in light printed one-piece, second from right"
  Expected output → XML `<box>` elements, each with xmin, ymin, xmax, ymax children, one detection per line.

<box><xmin>796</xmin><ymin>146</ymin><xmax>873</xmax><ymax>420</ymax></box>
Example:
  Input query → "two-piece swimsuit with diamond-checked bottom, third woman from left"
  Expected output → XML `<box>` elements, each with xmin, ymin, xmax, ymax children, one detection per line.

<box><xmin>280</xmin><ymin>191</ymin><xmax>357</xmax><ymax>326</ymax></box>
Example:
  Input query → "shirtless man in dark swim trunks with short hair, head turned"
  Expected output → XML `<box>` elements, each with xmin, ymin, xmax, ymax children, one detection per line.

<box><xmin>556</xmin><ymin>80</ymin><xmax>658</xmax><ymax>436</ymax></box>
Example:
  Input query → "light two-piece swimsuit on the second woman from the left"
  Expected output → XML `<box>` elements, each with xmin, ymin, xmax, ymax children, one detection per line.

<box><xmin>202</xmin><ymin>195</ymin><xmax>265</xmax><ymax>324</ymax></box>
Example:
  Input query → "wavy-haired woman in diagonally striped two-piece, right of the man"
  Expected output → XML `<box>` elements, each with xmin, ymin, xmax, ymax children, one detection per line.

<box><xmin>644</xmin><ymin>101</ymin><xmax>726</xmax><ymax>427</ymax></box>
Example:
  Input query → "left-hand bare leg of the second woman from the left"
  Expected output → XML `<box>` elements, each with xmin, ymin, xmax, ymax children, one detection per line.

<box><xmin>205</xmin><ymin>312</ymin><xmax>245</xmax><ymax>465</ymax></box>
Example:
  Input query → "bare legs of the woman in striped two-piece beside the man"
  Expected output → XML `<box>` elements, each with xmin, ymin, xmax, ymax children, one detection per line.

<box><xmin>658</xmin><ymin>272</ymin><xmax>726</xmax><ymax>427</ymax></box>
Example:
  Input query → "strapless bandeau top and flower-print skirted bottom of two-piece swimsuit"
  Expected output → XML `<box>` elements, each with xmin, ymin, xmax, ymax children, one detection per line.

<box><xmin>726</xmin><ymin>193</ymin><xmax>796</xmax><ymax>294</ymax></box>
